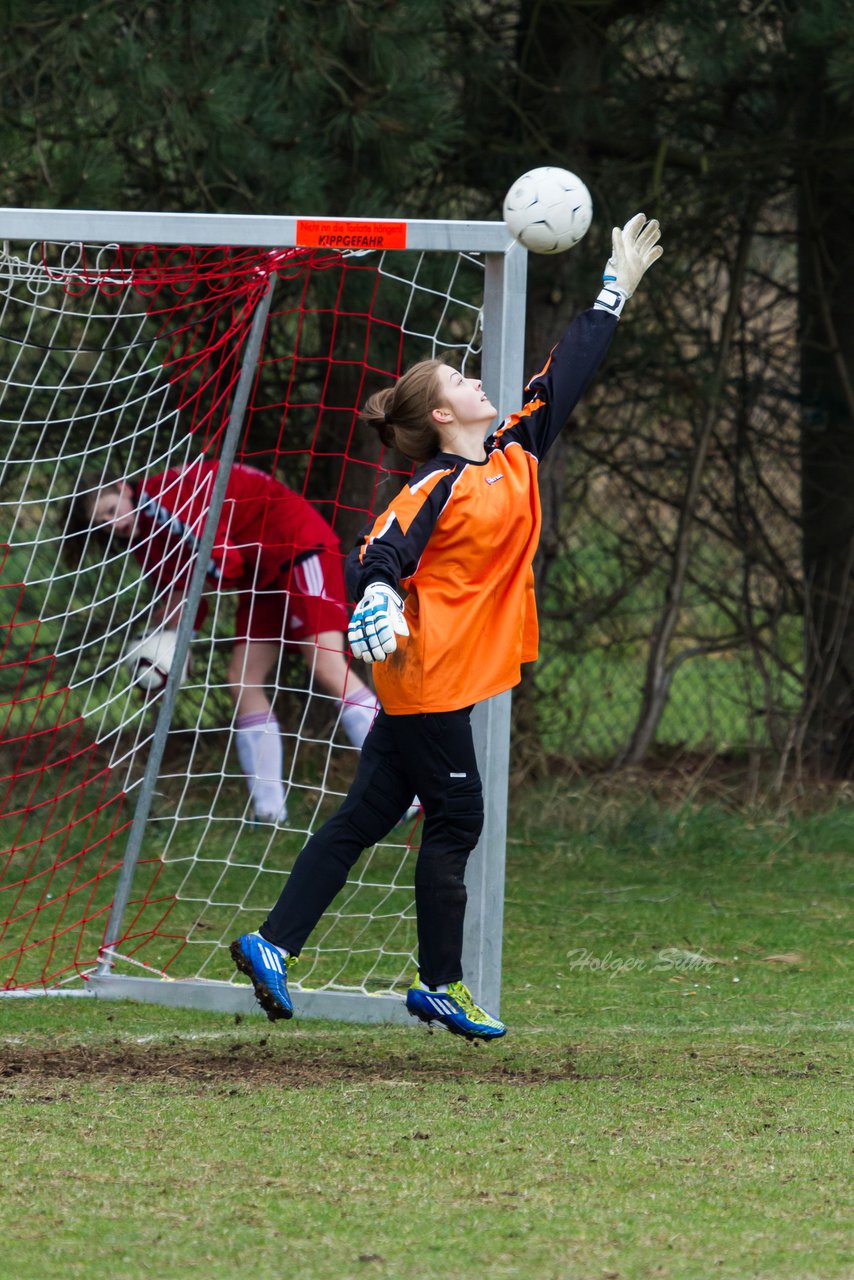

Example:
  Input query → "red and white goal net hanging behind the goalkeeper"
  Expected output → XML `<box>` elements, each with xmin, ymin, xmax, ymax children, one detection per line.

<box><xmin>0</xmin><ymin>211</ymin><xmax>521</xmax><ymax>1016</ymax></box>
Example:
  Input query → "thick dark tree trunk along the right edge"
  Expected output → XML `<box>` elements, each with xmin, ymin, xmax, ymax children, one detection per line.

<box><xmin>793</xmin><ymin>4</ymin><xmax>854</xmax><ymax>776</ymax></box>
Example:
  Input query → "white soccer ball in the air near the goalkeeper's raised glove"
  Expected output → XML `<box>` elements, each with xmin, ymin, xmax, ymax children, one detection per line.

<box><xmin>504</xmin><ymin>165</ymin><xmax>593</xmax><ymax>253</ymax></box>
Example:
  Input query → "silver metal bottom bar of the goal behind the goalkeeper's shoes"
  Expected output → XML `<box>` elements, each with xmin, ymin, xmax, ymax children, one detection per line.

<box><xmin>86</xmin><ymin>974</ymin><xmax>412</xmax><ymax>1025</ymax></box>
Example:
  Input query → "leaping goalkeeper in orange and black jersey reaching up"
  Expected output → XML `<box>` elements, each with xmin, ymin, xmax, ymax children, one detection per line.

<box><xmin>232</xmin><ymin>214</ymin><xmax>662</xmax><ymax>1039</ymax></box>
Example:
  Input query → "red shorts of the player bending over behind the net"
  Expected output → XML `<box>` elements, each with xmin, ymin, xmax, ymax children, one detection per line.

<box><xmin>234</xmin><ymin>550</ymin><xmax>350</xmax><ymax>644</ymax></box>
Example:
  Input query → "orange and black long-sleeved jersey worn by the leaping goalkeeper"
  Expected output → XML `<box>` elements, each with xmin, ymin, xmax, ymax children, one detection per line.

<box><xmin>347</xmin><ymin>308</ymin><xmax>617</xmax><ymax>716</ymax></box>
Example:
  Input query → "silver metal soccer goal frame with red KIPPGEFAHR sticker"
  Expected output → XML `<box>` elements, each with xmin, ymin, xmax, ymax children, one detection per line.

<box><xmin>0</xmin><ymin>209</ymin><xmax>526</xmax><ymax>1023</ymax></box>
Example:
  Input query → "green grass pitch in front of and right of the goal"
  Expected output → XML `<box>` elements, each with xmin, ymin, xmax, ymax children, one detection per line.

<box><xmin>0</xmin><ymin>785</ymin><xmax>854</xmax><ymax>1280</ymax></box>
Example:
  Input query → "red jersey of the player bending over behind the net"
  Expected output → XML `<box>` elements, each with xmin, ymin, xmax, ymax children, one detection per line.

<box><xmin>131</xmin><ymin>458</ymin><xmax>339</xmax><ymax>609</ymax></box>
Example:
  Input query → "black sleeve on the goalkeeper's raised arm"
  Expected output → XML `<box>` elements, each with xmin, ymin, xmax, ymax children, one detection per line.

<box><xmin>488</xmin><ymin>307</ymin><xmax>617</xmax><ymax>458</ymax></box>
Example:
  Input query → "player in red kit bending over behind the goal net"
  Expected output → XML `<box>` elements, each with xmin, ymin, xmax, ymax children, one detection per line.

<box><xmin>72</xmin><ymin>460</ymin><xmax>378</xmax><ymax>822</ymax></box>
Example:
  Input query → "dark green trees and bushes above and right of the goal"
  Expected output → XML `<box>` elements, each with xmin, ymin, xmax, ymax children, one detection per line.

<box><xmin>0</xmin><ymin>0</ymin><xmax>854</xmax><ymax>773</ymax></box>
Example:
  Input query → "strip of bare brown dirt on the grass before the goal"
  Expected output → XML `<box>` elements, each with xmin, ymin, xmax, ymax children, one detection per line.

<box><xmin>0</xmin><ymin>1039</ymin><xmax>579</xmax><ymax>1096</ymax></box>
